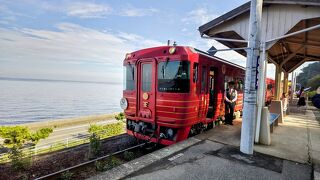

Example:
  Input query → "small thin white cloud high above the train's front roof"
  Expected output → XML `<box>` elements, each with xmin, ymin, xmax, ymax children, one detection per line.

<box><xmin>119</xmin><ymin>6</ymin><xmax>158</xmax><ymax>17</ymax></box>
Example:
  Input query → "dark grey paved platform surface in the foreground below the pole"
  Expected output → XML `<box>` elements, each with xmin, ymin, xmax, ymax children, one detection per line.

<box><xmin>126</xmin><ymin>140</ymin><xmax>311</xmax><ymax>180</ymax></box>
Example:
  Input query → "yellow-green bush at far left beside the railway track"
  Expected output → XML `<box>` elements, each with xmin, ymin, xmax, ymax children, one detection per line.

<box><xmin>0</xmin><ymin>126</ymin><xmax>53</xmax><ymax>170</ymax></box>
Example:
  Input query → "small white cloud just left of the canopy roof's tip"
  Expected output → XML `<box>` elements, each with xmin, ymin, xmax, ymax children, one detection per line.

<box><xmin>182</xmin><ymin>8</ymin><xmax>218</xmax><ymax>25</ymax></box>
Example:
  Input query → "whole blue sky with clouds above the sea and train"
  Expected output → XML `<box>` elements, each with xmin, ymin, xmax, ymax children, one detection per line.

<box><xmin>0</xmin><ymin>0</ymin><xmax>282</xmax><ymax>82</ymax></box>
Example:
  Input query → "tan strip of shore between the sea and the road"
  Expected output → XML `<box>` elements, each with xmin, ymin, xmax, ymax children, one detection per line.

<box><xmin>8</xmin><ymin>112</ymin><xmax>119</xmax><ymax>130</ymax></box>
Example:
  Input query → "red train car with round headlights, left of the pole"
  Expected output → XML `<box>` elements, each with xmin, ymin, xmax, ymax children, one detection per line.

<box><xmin>120</xmin><ymin>46</ymin><xmax>274</xmax><ymax>145</ymax></box>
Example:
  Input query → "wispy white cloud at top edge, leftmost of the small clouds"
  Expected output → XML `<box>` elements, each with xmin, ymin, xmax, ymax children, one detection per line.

<box><xmin>66</xmin><ymin>2</ymin><xmax>112</xmax><ymax>18</ymax></box>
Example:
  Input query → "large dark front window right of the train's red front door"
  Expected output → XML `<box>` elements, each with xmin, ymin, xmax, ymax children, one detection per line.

<box><xmin>158</xmin><ymin>61</ymin><xmax>190</xmax><ymax>93</ymax></box>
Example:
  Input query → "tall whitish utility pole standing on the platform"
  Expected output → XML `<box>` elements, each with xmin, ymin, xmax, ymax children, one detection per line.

<box><xmin>240</xmin><ymin>0</ymin><xmax>263</xmax><ymax>154</ymax></box>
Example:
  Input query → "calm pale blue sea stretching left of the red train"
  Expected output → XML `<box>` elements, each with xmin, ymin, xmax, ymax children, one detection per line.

<box><xmin>0</xmin><ymin>80</ymin><xmax>122</xmax><ymax>125</ymax></box>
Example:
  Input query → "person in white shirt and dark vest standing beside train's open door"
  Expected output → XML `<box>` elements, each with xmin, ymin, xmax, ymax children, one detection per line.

<box><xmin>224</xmin><ymin>81</ymin><xmax>238</xmax><ymax>125</ymax></box>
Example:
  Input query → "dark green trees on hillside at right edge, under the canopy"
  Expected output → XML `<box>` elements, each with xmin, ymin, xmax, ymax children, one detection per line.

<box><xmin>297</xmin><ymin>62</ymin><xmax>320</xmax><ymax>87</ymax></box>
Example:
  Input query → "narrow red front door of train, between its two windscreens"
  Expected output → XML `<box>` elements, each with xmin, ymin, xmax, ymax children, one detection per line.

<box><xmin>137</xmin><ymin>59</ymin><xmax>156</xmax><ymax>124</ymax></box>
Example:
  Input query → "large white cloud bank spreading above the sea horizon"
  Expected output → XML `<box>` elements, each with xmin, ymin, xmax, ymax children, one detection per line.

<box><xmin>0</xmin><ymin>23</ymin><xmax>161</xmax><ymax>81</ymax></box>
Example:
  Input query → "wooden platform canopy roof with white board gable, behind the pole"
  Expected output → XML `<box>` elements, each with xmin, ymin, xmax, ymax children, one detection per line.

<box><xmin>199</xmin><ymin>0</ymin><xmax>320</xmax><ymax>72</ymax></box>
